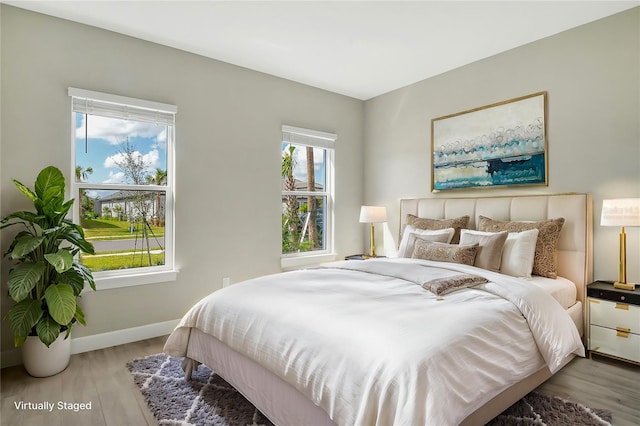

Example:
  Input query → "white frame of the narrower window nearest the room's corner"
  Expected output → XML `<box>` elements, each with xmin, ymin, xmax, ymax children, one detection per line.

<box><xmin>280</xmin><ymin>125</ymin><xmax>338</xmax><ymax>268</ymax></box>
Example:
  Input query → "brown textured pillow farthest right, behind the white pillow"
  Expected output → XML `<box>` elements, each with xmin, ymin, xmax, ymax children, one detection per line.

<box><xmin>478</xmin><ymin>216</ymin><xmax>564</xmax><ymax>278</ymax></box>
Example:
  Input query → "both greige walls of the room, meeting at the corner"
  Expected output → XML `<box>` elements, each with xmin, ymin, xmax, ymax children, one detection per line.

<box><xmin>0</xmin><ymin>5</ymin><xmax>640</xmax><ymax>351</ymax></box>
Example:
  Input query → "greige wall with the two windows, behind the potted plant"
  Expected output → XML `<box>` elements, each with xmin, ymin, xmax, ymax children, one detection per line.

<box><xmin>0</xmin><ymin>5</ymin><xmax>364</xmax><ymax>351</ymax></box>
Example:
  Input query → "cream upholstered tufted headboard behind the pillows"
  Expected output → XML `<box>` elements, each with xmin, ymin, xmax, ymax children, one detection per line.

<box><xmin>400</xmin><ymin>194</ymin><xmax>593</xmax><ymax>306</ymax></box>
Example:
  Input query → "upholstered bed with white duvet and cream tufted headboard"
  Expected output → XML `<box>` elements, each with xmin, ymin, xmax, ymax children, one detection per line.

<box><xmin>164</xmin><ymin>194</ymin><xmax>592</xmax><ymax>425</ymax></box>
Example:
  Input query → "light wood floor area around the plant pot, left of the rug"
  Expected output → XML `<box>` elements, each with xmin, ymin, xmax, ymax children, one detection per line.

<box><xmin>0</xmin><ymin>337</ymin><xmax>166</xmax><ymax>426</ymax></box>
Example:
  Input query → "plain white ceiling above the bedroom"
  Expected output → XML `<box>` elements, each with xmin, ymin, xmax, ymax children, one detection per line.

<box><xmin>4</xmin><ymin>0</ymin><xmax>640</xmax><ymax>100</ymax></box>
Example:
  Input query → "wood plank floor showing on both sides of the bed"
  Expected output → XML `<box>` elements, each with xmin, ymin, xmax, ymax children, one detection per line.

<box><xmin>0</xmin><ymin>337</ymin><xmax>640</xmax><ymax>426</ymax></box>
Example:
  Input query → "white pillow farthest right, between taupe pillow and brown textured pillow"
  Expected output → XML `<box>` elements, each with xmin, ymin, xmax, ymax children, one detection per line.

<box><xmin>500</xmin><ymin>229</ymin><xmax>538</xmax><ymax>278</ymax></box>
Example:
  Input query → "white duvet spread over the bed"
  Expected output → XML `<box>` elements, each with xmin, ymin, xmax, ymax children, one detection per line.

<box><xmin>165</xmin><ymin>259</ymin><xmax>584</xmax><ymax>425</ymax></box>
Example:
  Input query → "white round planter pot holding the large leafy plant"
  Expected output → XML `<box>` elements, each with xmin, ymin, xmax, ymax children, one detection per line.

<box><xmin>22</xmin><ymin>332</ymin><xmax>71</xmax><ymax>377</ymax></box>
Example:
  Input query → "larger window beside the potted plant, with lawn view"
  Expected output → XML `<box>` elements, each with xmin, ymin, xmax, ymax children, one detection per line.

<box><xmin>69</xmin><ymin>88</ymin><xmax>177</xmax><ymax>288</ymax></box>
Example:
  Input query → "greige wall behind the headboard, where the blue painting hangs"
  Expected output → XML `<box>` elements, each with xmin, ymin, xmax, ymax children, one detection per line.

<box><xmin>364</xmin><ymin>8</ymin><xmax>640</xmax><ymax>282</ymax></box>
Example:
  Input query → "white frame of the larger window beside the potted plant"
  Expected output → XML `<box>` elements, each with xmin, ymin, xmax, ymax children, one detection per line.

<box><xmin>68</xmin><ymin>87</ymin><xmax>178</xmax><ymax>290</ymax></box>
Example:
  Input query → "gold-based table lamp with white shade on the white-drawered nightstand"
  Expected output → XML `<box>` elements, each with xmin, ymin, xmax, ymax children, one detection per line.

<box><xmin>600</xmin><ymin>198</ymin><xmax>640</xmax><ymax>291</ymax></box>
